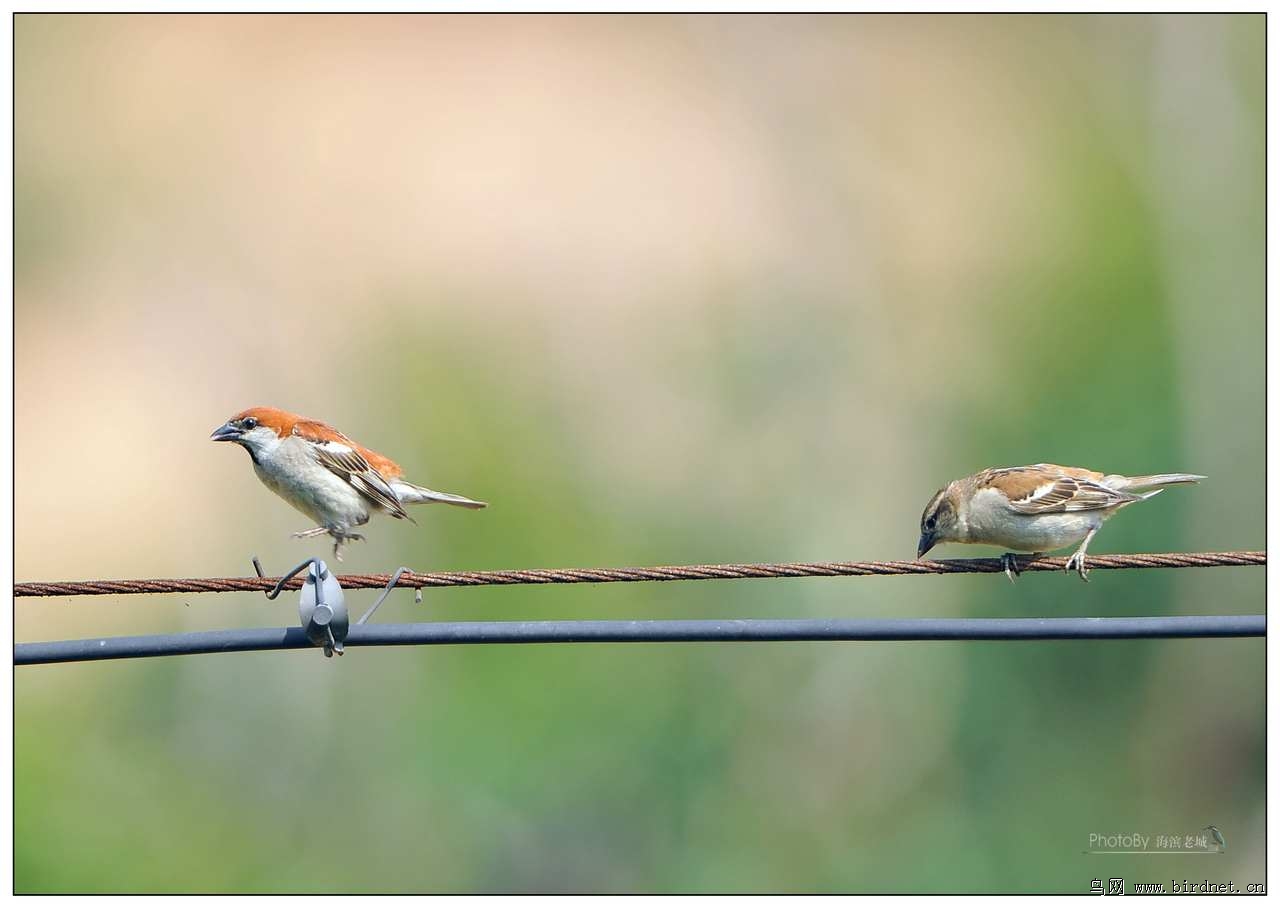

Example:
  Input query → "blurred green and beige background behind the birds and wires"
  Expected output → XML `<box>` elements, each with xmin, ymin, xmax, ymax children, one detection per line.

<box><xmin>14</xmin><ymin>15</ymin><xmax>1266</xmax><ymax>893</ymax></box>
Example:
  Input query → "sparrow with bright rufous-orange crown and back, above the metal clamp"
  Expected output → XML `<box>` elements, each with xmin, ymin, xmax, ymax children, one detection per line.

<box><xmin>210</xmin><ymin>407</ymin><xmax>485</xmax><ymax>561</ymax></box>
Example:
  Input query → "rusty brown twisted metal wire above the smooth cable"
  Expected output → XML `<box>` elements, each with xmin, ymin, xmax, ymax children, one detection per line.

<box><xmin>13</xmin><ymin>552</ymin><xmax>1267</xmax><ymax>597</ymax></box>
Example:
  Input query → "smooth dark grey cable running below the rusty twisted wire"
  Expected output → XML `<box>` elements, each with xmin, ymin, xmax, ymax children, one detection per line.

<box><xmin>13</xmin><ymin>615</ymin><xmax>1266</xmax><ymax>665</ymax></box>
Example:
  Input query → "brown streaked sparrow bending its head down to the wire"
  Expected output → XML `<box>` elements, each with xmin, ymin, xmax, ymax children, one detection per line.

<box><xmin>916</xmin><ymin>464</ymin><xmax>1204</xmax><ymax>580</ymax></box>
